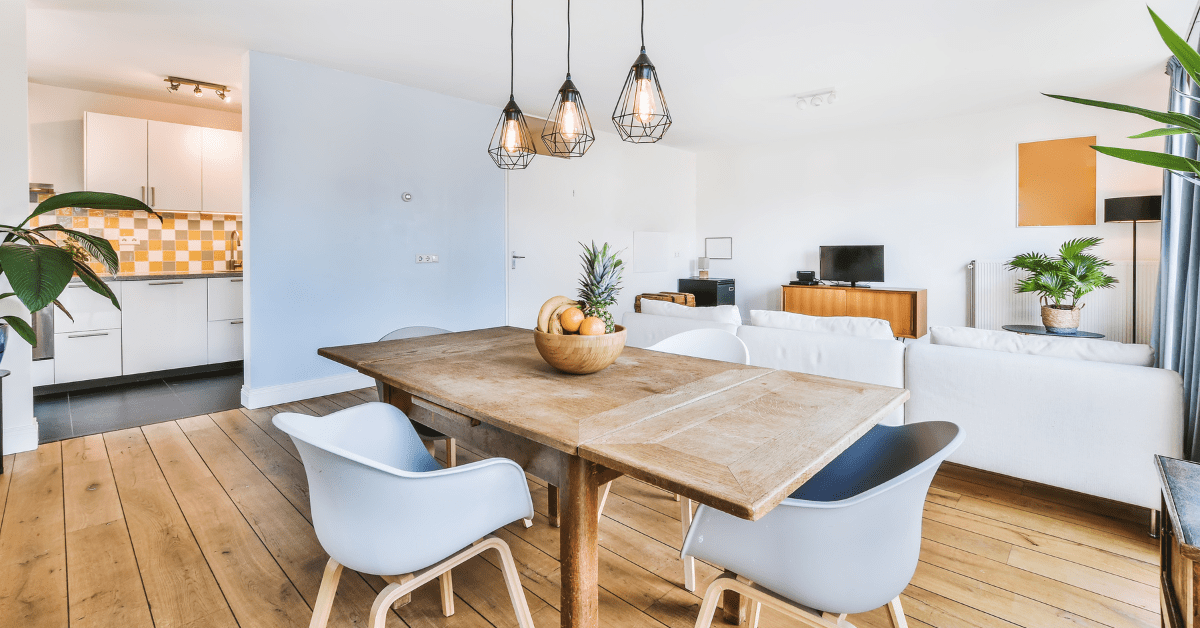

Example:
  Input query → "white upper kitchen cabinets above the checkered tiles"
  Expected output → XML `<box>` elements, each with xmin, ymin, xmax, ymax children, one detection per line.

<box><xmin>84</xmin><ymin>112</ymin><xmax>241</xmax><ymax>214</ymax></box>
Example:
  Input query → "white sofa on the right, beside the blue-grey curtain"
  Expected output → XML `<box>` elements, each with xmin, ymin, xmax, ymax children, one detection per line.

<box><xmin>905</xmin><ymin>329</ymin><xmax>1183</xmax><ymax>509</ymax></box>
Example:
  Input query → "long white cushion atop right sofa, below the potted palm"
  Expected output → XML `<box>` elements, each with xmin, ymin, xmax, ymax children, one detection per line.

<box><xmin>929</xmin><ymin>327</ymin><xmax>1154</xmax><ymax>366</ymax></box>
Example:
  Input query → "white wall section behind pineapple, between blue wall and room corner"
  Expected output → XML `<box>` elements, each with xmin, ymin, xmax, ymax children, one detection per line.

<box><xmin>509</xmin><ymin>130</ymin><xmax>696</xmax><ymax>329</ymax></box>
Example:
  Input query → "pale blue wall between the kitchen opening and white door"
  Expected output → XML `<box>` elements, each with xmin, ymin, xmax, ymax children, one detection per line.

<box><xmin>242</xmin><ymin>52</ymin><xmax>505</xmax><ymax>407</ymax></box>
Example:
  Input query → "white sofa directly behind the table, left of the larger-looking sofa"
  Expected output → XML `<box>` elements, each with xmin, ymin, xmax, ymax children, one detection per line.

<box><xmin>622</xmin><ymin>312</ymin><xmax>904</xmax><ymax>425</ymax></box>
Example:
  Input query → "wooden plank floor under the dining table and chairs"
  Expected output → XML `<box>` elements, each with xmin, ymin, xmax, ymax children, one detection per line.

<box><xmin>0</xmin><ymin>389</ymin><xmax>1159</xmax><ymax>628</ymax></box>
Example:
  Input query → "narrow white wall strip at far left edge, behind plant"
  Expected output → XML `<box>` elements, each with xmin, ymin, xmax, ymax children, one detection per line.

<box><xmin>0</xmin><ymin>0</ymin><xmax>37</xmax><ymax>454</ymax></box>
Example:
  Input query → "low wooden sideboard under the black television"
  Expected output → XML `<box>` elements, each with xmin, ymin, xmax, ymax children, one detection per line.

<box><xmin>782</xmin><ymin>285</ymin><xmax>929</xmax><ymax>337</ymax></box>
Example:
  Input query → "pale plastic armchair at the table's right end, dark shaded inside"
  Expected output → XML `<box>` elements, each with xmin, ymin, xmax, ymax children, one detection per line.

<box><xmin>680</xmin><ymin>421</ymin><xmax>962</xmax><ymax>628</ymax></box>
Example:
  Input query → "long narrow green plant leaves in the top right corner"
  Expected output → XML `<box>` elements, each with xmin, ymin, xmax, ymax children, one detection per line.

<box><xmin>1046</xmin><ymin>7</ymin><xmax>1200</xmax><ymax>178</ymax></box>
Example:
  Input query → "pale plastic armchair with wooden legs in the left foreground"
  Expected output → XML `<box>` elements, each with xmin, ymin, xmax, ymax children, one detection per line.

<box><xmin>272</xmin><ymin>402</ymin><xmax>533</xmax><ymax>628</ymax></box>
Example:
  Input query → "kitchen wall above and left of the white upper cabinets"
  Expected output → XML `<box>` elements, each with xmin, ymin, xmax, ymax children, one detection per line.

<box><xmin>29</xmin><ymin>83</ymin><xmax>241</xmax><ymax>193</ymax></box>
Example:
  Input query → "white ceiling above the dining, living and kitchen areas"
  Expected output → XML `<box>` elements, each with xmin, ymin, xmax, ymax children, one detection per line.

<box><xmin>29</xmin><ymin>0</ymin><xmax>1195</xmax><ymax>150</ymax></box>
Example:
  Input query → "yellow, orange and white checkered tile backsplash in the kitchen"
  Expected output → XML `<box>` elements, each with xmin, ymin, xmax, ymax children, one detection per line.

<box><xmin>29</xmin><ymin>208</ymin><xmax>241</xmax><ymax>276</ymax></box>
